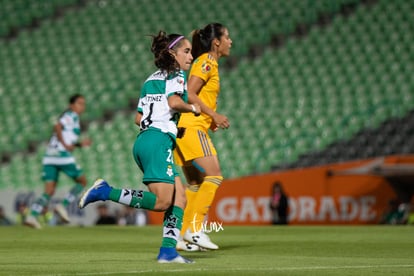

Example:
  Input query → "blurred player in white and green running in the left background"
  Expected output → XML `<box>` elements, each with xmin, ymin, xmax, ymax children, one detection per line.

<box><xmin>24</xmin><ymin>94</ymin><xmax>91</xmax><ymax>229</ymax></box>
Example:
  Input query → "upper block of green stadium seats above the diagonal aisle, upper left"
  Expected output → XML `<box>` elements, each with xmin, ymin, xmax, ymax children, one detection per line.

<box><xmin>0</xmin><ymin>0</ymin><xmax>360</xmax><ymax>156</ymax></box>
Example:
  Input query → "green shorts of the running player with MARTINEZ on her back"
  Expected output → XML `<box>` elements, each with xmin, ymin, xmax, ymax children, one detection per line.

<box><xmin>132</xmin><ymin>129</ymin><xmax>178</xmax><ymax>185</ymax></box>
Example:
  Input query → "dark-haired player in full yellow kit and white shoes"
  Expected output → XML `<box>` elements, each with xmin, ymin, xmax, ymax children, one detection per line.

<box><xmin>174</xmin><ymin>23</ymin><xmax>232</xmax><ymax>251</ymax></box>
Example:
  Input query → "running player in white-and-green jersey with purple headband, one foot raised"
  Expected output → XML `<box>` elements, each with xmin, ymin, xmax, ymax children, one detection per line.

<box><xmin>79</xmin><ymin>31</ymin><xmax>201</xmax><ymax>263</ymax></box>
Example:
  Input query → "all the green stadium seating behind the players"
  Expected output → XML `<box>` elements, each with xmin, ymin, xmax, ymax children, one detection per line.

<box><xmin>0</xmin><ymin>0</ymin><xmax>414</xmax><ymax>190</ymax></box>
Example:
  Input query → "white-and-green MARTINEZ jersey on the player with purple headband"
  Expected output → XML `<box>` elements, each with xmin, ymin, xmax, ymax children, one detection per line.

<box><xmin>137</xmin><ymin>70</ymin><xmax>188</xmax><ymax>136</ymax></box>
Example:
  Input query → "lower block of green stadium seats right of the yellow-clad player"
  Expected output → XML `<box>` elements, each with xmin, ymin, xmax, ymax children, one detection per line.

<box><xmin>213</xmin><ymin>1</ymin><xmax>414</xmax><ymax>174</ymax></box>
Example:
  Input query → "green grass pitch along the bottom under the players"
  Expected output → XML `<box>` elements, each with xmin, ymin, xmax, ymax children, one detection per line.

<box><xmin>0</xmin><ymin>225</ymin><xmax>414</xmax><ymax>276</ymax></box>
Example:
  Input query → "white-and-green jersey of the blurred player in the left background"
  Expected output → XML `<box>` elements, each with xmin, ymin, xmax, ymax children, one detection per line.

<box><xmin>43</xmin><ymin>110</ymin><xmax>80</xmax><ymax>165</ymax></box>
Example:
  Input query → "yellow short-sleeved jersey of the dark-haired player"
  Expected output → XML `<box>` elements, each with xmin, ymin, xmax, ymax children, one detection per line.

<box><xmin>178</xmin><ymin>53</ymin><xmax>220</xmax><ymax>131</ymax></box>
